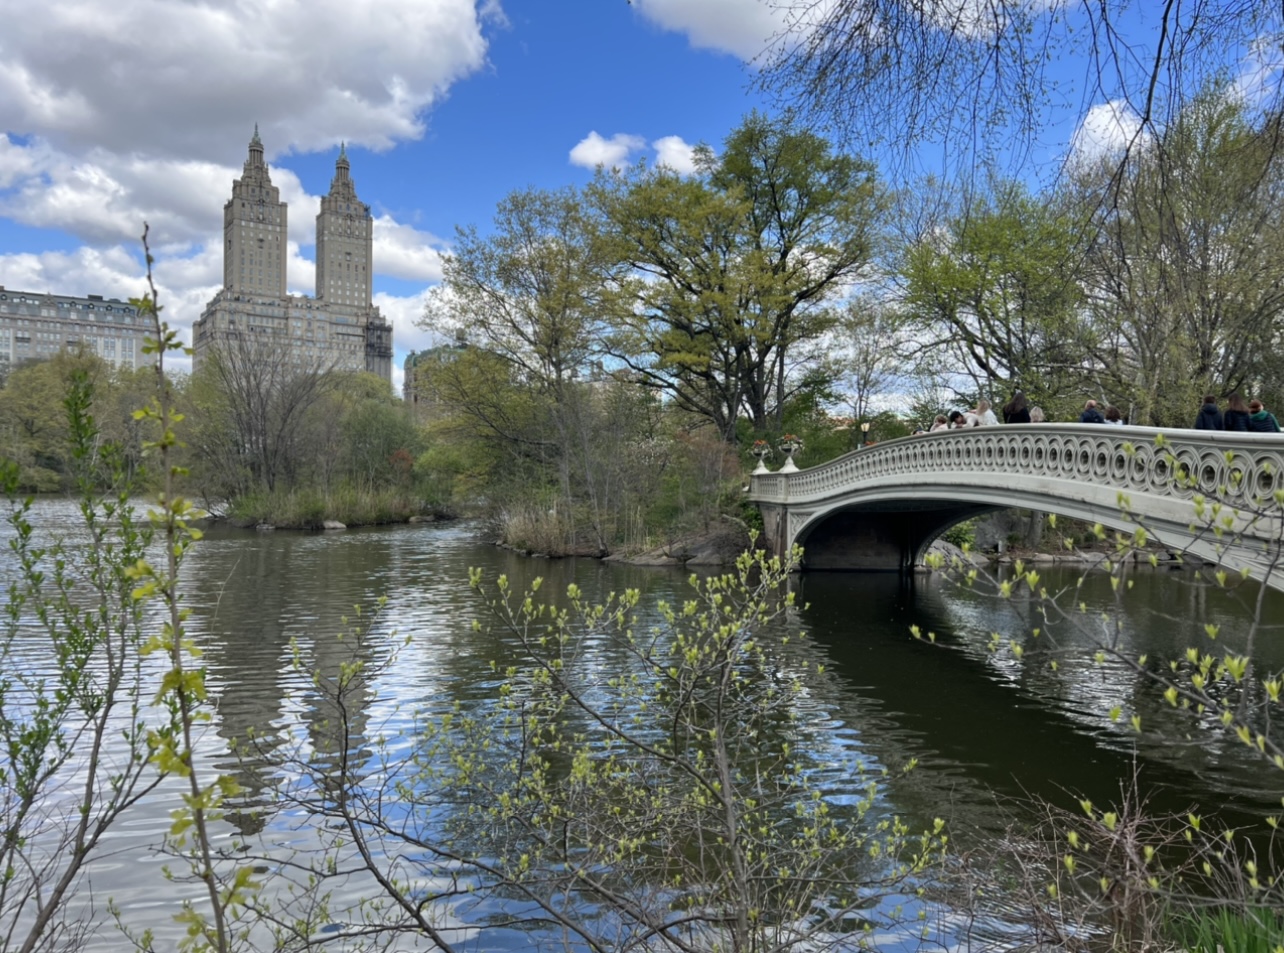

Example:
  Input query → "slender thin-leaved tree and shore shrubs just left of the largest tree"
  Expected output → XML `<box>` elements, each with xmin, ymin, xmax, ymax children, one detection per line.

<box><xmin>416</xmin><ymin>189</ymin><xmax>739</xmax><ymax>555</ymax></box>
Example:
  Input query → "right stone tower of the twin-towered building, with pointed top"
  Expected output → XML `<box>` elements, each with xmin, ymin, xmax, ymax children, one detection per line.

<box><xmin>317</xmin><ymin>145</ymin><xmax>374</xmax><ymax>308</ymax></box>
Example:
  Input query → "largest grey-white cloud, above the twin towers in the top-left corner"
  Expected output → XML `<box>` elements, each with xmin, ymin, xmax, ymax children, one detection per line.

<box><xmin>0</xmin><ymin>0</ymin><xmax>487</xmax><ymax>158</ymax></box>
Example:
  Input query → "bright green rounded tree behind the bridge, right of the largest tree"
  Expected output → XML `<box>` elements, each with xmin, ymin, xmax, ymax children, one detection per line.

<box><xmin>901</xmin><ymin>184</ymin><xmax>1085</xmax><ymax>401</ymax></box>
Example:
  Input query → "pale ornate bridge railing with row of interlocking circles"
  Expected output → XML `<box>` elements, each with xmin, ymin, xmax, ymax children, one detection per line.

<box><xmin>749</xmin><ymin>424</ymin><xmax>1284</xmax><ymax>505</ymax></box>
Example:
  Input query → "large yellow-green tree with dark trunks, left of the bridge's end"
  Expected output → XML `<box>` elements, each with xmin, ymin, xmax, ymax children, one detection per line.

<box><xmin>591</xmin><ymin>113</ymin><xmax>885</xmax><ymax>441</ymax></box>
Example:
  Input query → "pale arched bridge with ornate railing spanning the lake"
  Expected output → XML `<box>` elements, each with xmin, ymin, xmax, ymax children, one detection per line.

<box><xmin>749</xmin><ymin>424</ymin><xmax>1284</xmax><ymax>588</ymax></box>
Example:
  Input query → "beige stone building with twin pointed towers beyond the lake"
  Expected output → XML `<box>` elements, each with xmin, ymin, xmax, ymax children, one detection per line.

<box><xmin>193</xmin><ymin>126</ymin><xmax>393</xmax><ymax>384</ymax></box>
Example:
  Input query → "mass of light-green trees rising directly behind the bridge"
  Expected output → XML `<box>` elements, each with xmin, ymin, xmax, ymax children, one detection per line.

<box><xmin>896</xmin><ymin>87</ymin><xmax>1284</xmax><ymax>426</ymax></box>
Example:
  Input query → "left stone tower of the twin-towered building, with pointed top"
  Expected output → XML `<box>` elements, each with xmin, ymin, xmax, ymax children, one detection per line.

<box><xmin>223</xmin><ymin>125</ymin><xmax>286</xmax><ymax>297</ymax></box>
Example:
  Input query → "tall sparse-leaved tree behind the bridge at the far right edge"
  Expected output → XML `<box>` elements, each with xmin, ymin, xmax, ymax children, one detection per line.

<box><xmin>1086</xmin><ymin>85</ymin><xmax>1284</xmax><ymax>425</ymax></box>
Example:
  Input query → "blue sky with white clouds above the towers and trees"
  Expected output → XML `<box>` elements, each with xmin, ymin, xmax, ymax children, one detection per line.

<box><xmin>0</xmin><ymin>0</ymin><xmax>1268</xmax><ymax>393</ymax></box>
